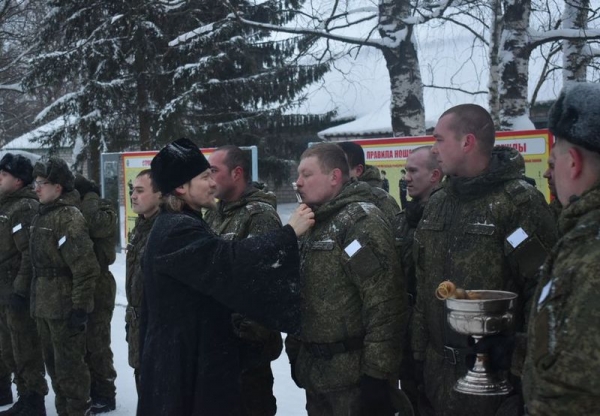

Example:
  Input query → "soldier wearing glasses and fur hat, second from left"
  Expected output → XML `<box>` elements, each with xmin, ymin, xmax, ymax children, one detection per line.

<box><xmin>29</xmin><ymin>157</ymin><xmax>100</xmax><ymax>416</ymax></box>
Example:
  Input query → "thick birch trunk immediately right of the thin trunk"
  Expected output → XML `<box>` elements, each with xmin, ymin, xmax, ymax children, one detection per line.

<box><xmin>499</xmin><ymin>0</ymin><xmax>533</xmax><ymax>130</ymax></box>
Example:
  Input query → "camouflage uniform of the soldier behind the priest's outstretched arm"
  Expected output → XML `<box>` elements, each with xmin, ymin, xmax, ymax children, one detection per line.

<box><xmin>205</xmin><ymin>185</ymin><xmax>283</xmax><ymax>416</ymax></box>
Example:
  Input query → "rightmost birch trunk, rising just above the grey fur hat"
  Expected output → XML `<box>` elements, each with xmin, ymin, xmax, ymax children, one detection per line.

<box><xmin>562</xmin><ymin>0</ymin><xmax>590</xmax><ymax>83</ymax></box>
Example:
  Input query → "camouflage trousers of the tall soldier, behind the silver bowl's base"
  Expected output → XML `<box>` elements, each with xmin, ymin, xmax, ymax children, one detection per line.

<box><xmin>419</xmin><ymin>346</ymin><xmax>523</xmax><ymax>416</ymax></box>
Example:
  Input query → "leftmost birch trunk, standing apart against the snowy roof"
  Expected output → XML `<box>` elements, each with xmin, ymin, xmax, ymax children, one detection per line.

<box><xmin>379</xmin><ymin>0</ymin><xmax>425</xmax><ymax>136</ymax></box>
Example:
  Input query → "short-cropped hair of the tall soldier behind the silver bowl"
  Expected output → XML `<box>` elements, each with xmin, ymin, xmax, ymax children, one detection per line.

<box><xmin>440</xmin><ymin>104</ymin><xmax>496</xmax><ymax>154</ymax></box>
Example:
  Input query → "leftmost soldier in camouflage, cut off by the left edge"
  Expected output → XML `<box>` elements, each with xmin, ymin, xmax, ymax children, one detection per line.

<box><xmin>0</xmin><ymin>153</ymin><xmax>48</xmax><ymax>416</ymax></box>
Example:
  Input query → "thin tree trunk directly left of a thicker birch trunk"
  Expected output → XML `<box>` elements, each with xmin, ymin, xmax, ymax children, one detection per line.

<box><xmin>488</xmin><ymin>0</ymin><xmax>502</xmax><ymax>128</ymax></box>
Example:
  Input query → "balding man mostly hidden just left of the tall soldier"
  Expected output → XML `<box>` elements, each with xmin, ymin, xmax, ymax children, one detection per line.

<box><xmin>400</xmin><ymin>146</ymin><xmax>444</xmax><ymax>415</ymax></box>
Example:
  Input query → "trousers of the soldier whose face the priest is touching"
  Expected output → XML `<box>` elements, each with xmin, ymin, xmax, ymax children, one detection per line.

<box><xmin>306</xmin><ymin>387</ymin><xmax>362</xmax><ymax>416</ymax></box>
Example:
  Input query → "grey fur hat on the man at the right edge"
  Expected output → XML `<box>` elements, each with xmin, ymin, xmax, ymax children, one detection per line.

<box><xmin>548</xmin><ymin>82</ymin><xmax>600</xmax><ymax>152</ymax></box>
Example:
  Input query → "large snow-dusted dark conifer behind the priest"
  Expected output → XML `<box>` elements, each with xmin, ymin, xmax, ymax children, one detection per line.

<box><xmin>25</xmin><ymin>0</ymin><xmax>332</xmax><ymax>178</ymax></box>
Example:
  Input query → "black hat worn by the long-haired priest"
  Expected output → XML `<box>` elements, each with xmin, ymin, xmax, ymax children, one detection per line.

<box><xmin>150</xmin><ymin>138</ymin><xmax>210</xmax><ymax>195</ymax></box>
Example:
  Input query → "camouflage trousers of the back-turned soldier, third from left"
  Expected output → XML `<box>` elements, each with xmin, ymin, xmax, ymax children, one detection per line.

<box><xmin>85</xmin><ymin>271</ymin><xmax>117</xmax><ymax>400</ymax></box>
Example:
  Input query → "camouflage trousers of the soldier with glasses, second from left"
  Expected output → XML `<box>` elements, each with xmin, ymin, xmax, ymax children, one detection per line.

<box><xmin>37</xmin><ymin>318</ymin><xmax>90</xmax><ymax>416</ymax></box>
